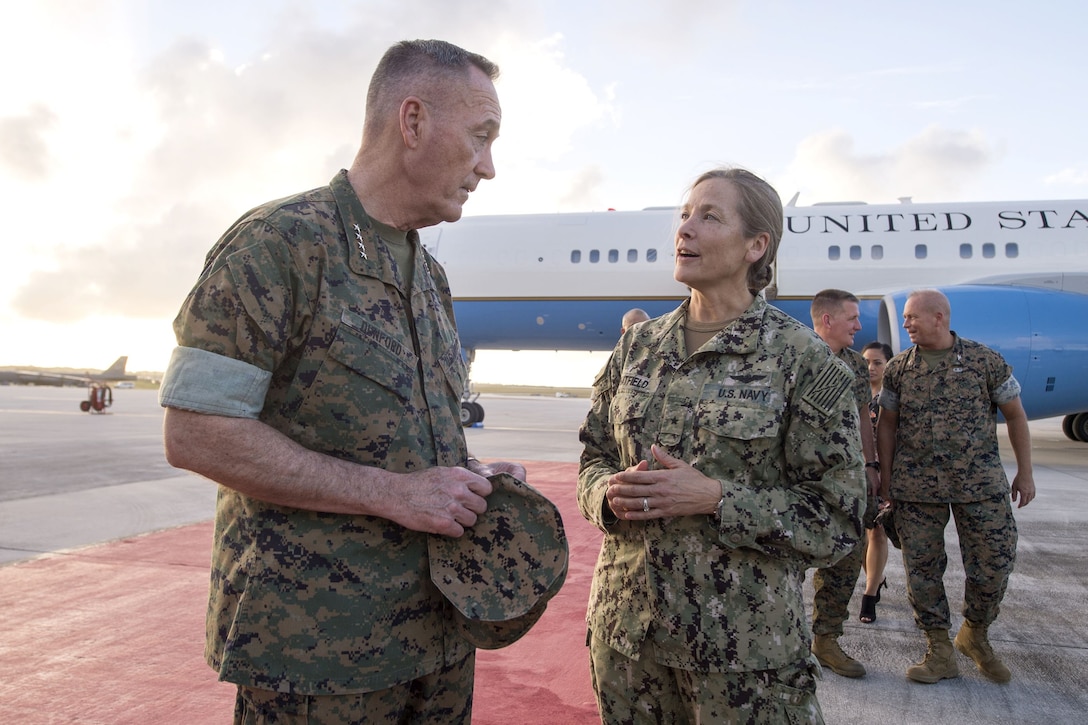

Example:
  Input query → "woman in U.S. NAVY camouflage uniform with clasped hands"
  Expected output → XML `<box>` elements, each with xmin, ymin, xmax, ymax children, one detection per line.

<box><xmin>578</xmin><ymin>169</ymin><xmax>865</xmax><ymax>723</ymax></box>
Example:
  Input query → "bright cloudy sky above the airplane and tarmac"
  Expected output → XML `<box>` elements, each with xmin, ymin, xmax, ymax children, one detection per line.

<box><xmin>0</xmin><ymin>0</ymin><xmax>1088</xmax><ymax>384</ymax></box>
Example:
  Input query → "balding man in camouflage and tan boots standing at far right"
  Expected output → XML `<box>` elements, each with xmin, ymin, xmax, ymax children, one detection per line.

<box><xmin>877</xmin><ymin>290</ymin><xmax>1035</xmax><ymax>683</ymax></box>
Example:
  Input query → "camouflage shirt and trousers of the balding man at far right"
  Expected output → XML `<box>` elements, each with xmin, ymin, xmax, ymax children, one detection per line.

<box><xmin>880</xmin><ymin>332</ymin><xmax>1021</xmax><ymax>629</ymax></box>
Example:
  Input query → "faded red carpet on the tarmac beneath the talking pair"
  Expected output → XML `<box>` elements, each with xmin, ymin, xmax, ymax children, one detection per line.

<box><xmin>0</xmin><ymin>462</ymin><xmax>601</xmax><ymax>725</ymax></box>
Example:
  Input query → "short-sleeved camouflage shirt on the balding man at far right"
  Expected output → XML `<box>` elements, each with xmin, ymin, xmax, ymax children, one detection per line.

<box><xmin>880</xmin><ymin>332</ymin><xmax>1021</xmax><ymax>502</ymax></box>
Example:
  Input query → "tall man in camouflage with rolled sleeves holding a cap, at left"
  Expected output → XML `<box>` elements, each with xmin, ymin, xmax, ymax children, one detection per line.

<box><xmin>161</xmin><ymin>40</ymin><xmax>524</xmax><ymax>723</ymax></box>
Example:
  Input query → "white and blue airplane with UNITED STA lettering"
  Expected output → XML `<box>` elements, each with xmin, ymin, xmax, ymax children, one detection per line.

<box><xmin>420</xmin><ymin>197</ymin><xmax>1088</xmax><ymax>442</ymax></box>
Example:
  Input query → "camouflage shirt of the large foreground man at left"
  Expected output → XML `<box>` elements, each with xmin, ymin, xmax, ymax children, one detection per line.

<box><xmin>168</xmin><ymin>171</ymin><xmax>473</xmax><ymax>695</ymax></box>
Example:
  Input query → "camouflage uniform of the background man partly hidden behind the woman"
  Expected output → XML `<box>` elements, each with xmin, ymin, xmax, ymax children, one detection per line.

<box><xmin>813</xmin><ymin>347</ymin><xmax>877</xmax><ymax>636</ymax></box>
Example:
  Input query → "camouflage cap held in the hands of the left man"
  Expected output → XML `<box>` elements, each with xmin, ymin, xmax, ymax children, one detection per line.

<box><xmin>428</xmin><ymin>474</ymin><xmax>568</xmax><ymax>650</ymax></box>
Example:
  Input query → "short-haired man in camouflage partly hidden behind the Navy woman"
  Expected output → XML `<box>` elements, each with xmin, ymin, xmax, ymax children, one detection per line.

<box><xmin>809</xmin><ymin>290</ymin><xmax>879</xmax><ymax>677</ymax></box>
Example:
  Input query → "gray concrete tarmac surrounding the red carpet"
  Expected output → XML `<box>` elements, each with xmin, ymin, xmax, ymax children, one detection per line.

<box><xmin>0</xmin><ymin>386</ymin><xmax>1088</xmax><ymax>725</ymax></box>
